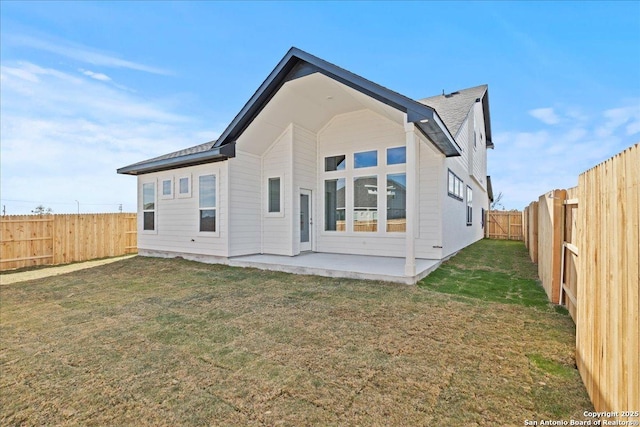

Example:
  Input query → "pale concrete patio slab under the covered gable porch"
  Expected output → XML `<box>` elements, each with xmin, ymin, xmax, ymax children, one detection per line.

<box><xmin>229</xmin><ymin>252</ymin><xmax>441</xmax><ymax>285</ymax></box>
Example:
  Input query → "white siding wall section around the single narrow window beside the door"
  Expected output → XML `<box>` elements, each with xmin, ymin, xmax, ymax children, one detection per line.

<box><xmin>256</xmin><ymin>126</ymin><xmax>294</xmax><ymax>255</ymax></box>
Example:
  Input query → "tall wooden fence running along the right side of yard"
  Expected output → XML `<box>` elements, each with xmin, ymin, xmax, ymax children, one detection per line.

<box><xmin>523</xmin><ymin>144</ymin><xmax>640</xmax><ymax>420</ymax></box>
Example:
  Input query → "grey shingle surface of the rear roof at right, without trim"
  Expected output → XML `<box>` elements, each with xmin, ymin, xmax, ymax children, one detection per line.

<box><xmin>418</xmin><ymin>85</ymin><xmax>487</xmax><ymax>137</ymax></box>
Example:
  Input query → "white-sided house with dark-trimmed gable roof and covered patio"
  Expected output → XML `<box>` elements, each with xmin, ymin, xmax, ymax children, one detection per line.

<box><xmin>118</xmin><ymin>48</ymin><xmax>493</xmax><ymax>283</ymax></box>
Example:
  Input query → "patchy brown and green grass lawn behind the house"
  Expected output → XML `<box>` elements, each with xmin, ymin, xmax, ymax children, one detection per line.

<box><xmin>0</xmin><ymin>241</ymin><xmax>592</xmax><ymax>426</ymax></box>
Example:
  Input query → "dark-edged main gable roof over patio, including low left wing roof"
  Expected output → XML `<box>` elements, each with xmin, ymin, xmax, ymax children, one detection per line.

<box><xmin>117</xmin><ymin>47</ymin><xmax>490</xmax><ymax>175</ymax></box>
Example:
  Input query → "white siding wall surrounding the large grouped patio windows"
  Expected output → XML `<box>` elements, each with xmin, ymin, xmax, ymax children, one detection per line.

<box><xmin>315</xmin><ymin>110</ymin><xmax>406</xmax><ymax>257</ymax></box>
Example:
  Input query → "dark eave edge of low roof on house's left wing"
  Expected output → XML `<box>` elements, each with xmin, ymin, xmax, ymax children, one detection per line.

<box><xmin>117</xmin><ymin>144</ymin><xmax>236</xmax><ymax>175</ymax></box>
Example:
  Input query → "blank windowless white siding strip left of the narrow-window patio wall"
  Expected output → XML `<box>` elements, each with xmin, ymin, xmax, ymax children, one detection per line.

<box><xmin>229</xmin><ymin>150</ymin><xmax>262</xmax><ymax>256</ymax></box>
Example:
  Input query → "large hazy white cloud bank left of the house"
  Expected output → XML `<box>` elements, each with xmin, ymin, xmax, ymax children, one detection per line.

<box><xmin>0</xmin><ymin>63</ymin><xmax>220</xmax><ymax>214</ymax></box>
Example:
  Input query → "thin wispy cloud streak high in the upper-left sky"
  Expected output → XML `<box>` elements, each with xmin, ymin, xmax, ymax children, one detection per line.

<box><xmin>3</xmin><ymin>34</ymin><xmax>171</xmax><ymax>75</ymax></box>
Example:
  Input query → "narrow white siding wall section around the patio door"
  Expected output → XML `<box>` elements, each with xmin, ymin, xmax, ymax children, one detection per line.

<box><xmin>291</xmin><ymin>125</ymin><xmax>318</xmax><ymax>254</ymax></box>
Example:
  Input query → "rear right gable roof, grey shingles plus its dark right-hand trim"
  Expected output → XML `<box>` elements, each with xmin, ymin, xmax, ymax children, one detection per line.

<box><xmin>419</xmin><ymin>85</ymin><xmax>493</xmax><ymax>148</ymax></box>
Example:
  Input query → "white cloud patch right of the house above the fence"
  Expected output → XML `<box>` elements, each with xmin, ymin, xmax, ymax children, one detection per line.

<box><xmin>489</xmin><ymin>103</ymin><xmax>640</xmax><ymax>209</ymax></box>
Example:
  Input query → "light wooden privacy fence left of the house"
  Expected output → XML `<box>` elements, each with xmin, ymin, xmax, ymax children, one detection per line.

<box><xmin>0</xmin><ymin>213</ymin><xmax>137</xmax><ymax>271</ymax></box>
